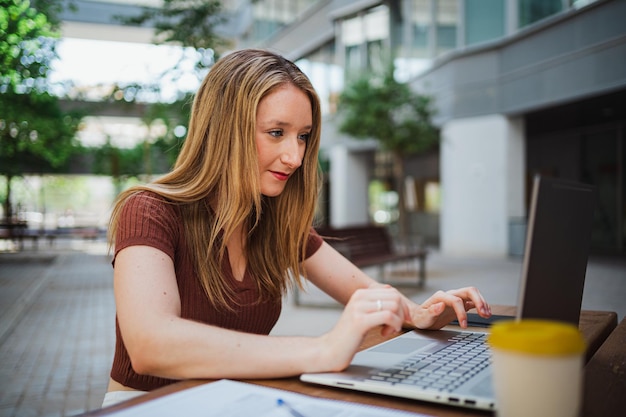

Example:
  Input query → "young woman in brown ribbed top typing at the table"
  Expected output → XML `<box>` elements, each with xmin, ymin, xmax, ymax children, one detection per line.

<box><xmin>105</xmin><ymin>50</ymin><xmax>491</xmax><ymax>404</ymax></box>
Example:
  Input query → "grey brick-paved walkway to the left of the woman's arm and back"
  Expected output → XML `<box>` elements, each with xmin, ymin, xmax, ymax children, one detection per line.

<box><xmin>0</xmin><ymin>240</ymin><xmax>115</xmax><ymax>417</ymax></box>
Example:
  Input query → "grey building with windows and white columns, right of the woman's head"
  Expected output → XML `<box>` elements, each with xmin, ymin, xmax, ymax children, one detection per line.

<box><xmin>257</xmin><ymin>0</ymin><xmax>626</xmax><ymax>256</ymax></box>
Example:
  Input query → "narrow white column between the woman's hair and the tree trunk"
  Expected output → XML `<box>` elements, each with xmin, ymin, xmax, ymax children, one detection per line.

<box><xmin>328</xmin><ymin>146</ymin><xmax>369</xmax><ymax>227</ymax></box>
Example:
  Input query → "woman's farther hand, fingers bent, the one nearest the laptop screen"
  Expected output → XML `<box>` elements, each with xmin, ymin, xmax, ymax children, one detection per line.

<box><xmin>405</xmin><ymin>287</ymin><xmax>491</xmax><ymax>330</ymax></box>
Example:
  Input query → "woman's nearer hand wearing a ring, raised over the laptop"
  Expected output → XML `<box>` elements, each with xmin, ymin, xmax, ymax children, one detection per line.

<box><xmin>320</xmin><ymin>286</ymin><xmax>409</xmax><ymax>372</ymax></box>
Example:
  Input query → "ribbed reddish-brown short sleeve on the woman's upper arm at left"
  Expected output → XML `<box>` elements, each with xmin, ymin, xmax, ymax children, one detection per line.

<box><xmin>115</xmin><ymin>192</ymin><xmax>181</xmax><ymax>259</ymax></box>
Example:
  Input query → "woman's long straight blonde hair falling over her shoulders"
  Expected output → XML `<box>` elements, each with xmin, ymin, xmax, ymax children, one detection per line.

<box><xmin>109</xmin><ymin>49</ymin><xmax>321</xmax><ymax>308</ymax></box>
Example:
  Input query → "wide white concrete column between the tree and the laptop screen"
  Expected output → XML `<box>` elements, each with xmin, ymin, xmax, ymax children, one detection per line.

<box><xmin>441</xmin><ymin>114</ymin><xmax>526</xmax><ymax>256</ymax></box>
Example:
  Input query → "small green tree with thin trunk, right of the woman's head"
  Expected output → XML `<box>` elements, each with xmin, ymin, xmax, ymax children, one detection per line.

<box><xmin>338</xmin><ymin>70</ymin><xmax>439</xmax><ymax>243</ymax></box>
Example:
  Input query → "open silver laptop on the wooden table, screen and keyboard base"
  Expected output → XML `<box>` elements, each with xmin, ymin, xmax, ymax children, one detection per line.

<box><xmin>300</xmin><ymin>176</ymin><xmax>595</xmax><ymax>410</ymax></box>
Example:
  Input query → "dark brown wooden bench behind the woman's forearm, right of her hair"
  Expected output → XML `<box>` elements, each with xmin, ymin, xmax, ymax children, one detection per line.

<box><xmin>317</xmin><ymin>225</ymin><xmax>428</xmax><ymax>287</ymax></box>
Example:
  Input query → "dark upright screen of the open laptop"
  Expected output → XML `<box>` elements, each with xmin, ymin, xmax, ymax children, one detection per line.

<box><xmin>518</xmin><ymin>176</ymin><xmax>595</xmax><ymax>325</ymax></box>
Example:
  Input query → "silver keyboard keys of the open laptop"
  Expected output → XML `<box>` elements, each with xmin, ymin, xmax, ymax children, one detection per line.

<box><xmin>367</xmin><ymin>333</ymin><xmax>491</xmax><ymax>391</ymax></box>
